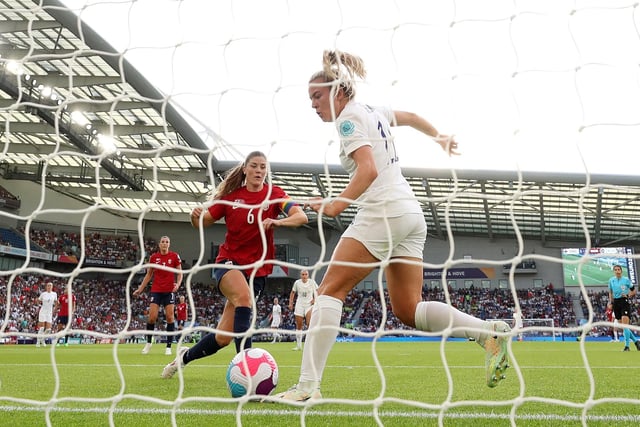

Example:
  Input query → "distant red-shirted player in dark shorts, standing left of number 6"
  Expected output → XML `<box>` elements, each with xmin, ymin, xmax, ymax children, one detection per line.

<box><xmin>133</xmin><ymin>236</ymin><xmax>182</xmax><ymax>355</ymax></box>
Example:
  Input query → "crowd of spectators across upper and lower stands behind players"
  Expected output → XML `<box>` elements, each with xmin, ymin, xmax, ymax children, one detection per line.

<box><xmin>0</xmin><ymin>226</ymin><xmax>624</xmax><ymax>337</ymax></box>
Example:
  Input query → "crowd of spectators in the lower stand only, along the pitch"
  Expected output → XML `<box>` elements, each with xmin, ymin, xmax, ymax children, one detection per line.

<box><xmin>0</xmin><ymin>275</ymin><xmax>592</xmax><ymax>340</ymax></box>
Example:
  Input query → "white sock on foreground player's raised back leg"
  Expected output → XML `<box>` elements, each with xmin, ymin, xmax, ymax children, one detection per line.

<box><xmin>415</xmin><ymin>301</ymin><xmax>488</xmax><ymax>345</ymax></box>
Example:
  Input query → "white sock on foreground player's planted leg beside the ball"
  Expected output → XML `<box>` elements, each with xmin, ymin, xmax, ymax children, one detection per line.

<box><xmin>298</xmin><ymin>295</ymin><xmax>342</xmax><ymax>391</ymax></box>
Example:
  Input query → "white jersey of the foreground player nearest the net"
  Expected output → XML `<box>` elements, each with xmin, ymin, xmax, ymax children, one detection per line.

<box><xmin>336</xmin><ymin>101</ymin><xmax>422</xmax><ymax>217</ymax></box>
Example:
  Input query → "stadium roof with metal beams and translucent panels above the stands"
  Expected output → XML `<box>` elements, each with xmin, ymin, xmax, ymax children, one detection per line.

<box><xmin>0</xmin><ymin>0</ymin><xmax>640</xmax><ymax>245</ymax></box>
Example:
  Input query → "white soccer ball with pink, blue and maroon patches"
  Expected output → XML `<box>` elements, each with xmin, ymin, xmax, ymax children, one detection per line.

<box><xmin>227</xmin><ymin>348</ymin><xmax>278</xmax><ymax>397</ymax></box>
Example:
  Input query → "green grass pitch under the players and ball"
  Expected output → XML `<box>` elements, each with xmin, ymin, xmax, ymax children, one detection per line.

<box><xmin>0</xmin><ymin>341</ymin><xmax>640</xmax><ymax>427</ymax></box>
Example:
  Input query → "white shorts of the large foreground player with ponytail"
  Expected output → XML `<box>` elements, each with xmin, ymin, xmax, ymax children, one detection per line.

<box><xmin>342</xmin><ymin>214</ymin><xmax>427</xmax><ymax>260</ymax></box>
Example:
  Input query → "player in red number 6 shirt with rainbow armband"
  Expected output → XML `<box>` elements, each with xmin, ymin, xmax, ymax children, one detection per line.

<box><xmin>162</xmin><ymin>151</ymin><xmax>308</xmax><ymax>378</ymax></box>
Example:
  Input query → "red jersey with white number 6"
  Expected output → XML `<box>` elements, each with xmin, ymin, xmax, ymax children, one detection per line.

<box><xmin>209</xmin><ymin>185</ymin><xmax>294</xmax><ymax>277</ymax></box>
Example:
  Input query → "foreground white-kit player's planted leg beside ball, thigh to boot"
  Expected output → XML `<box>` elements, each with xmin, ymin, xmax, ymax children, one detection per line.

<box><xmin>281</xmin><ymin>237</ymin><xmax>377</xmax><ymax>401</ymax></box>
